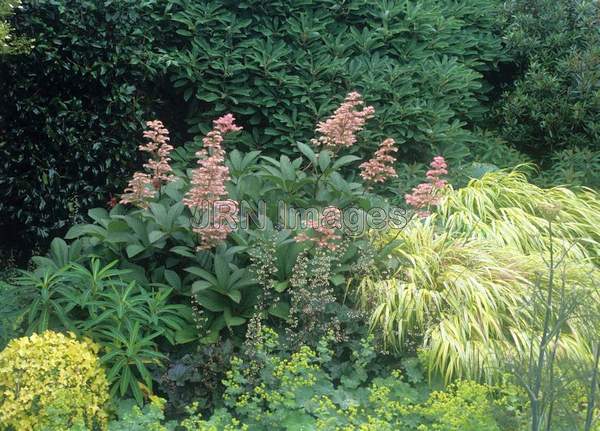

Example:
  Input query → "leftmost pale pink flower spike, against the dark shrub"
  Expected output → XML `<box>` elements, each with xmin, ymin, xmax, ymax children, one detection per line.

<box><xmin>120</xmin><ymin>120</ymin><xmax>174</xmax><ymax>208</ymax></box>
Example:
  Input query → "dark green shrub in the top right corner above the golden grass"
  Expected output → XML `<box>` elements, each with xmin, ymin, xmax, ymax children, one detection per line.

<box><xmin>495</xmin><ymin>0</ymin><xmax>600</xmax><ymax>159</ymax></box>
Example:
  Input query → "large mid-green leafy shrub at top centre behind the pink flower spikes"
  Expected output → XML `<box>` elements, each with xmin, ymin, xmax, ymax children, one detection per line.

<box><xmin>166</xmin><ymin>0</ymin><xmax>503</xmax><ymax>159</ymax></box>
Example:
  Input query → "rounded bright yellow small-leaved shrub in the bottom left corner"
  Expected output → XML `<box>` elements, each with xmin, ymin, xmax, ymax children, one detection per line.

<box><xmin>0</xmin><ymin>331</ymin><xmax>108</xmax><ymax>430</ymax></box>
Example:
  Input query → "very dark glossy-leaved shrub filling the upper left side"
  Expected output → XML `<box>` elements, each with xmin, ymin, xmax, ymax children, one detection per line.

<box><xmin>0</xmin><ymin>0</ymin><xmax>170</xmax><ymax>250</ymax></box>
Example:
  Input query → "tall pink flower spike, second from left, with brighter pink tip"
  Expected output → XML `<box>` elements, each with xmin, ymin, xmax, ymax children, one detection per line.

<box><xmin>183</xmin><ymin>114</ymin><xmax>242</xmax><ymax>249</ymax></box>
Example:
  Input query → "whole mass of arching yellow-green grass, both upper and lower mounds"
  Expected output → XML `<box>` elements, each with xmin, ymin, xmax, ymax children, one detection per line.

<box><xmin>357</xmin><ymin>171</ymin><xmax>600</xmax><ymax>381</ymax></box>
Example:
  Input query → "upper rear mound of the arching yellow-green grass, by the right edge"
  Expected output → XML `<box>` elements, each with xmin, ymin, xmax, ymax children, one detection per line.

<box><xmin>436</xmin><ymin>170</ymin><xmax>600</xmax><ymax>264</ymax></box>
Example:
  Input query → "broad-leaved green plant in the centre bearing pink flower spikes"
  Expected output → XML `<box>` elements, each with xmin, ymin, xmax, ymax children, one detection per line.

<box><xmin>29</xmin><ymin>92</ymin><xmax>412</xmax><ymax>374</ymax></box>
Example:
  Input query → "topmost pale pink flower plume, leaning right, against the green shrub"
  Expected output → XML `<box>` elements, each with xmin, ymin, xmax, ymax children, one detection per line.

<box><xmin>311</xmin><ymin>92</ymin><xmax>375</xmax><ymax>151</ymax></box>
